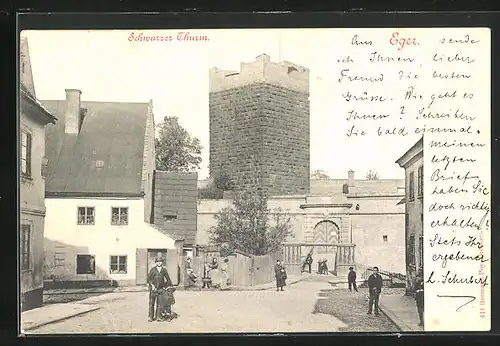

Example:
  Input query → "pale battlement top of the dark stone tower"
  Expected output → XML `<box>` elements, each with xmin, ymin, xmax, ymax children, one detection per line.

<box><xmin>209</xmin><ymin>54</ymin><xmax>309</xmax><ymax>94</ymax></box>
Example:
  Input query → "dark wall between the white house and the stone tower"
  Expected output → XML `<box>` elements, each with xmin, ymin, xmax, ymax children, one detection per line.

<box><xmin>154</xmin><ymin>171</ymin><xmax>198</xmax><ymax>247</ymax></box>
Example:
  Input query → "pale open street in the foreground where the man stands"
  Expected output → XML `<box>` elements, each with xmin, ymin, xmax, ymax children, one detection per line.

<box><xmin>29</xmin><ymin>282</ymin><xmax>395</xmax><ymax>334</ymax></box>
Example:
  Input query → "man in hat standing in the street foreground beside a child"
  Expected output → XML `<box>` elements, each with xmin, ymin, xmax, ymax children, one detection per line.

<box><xmin>148</xmin><ymin>257</ymin><xmax>172</xmax><ymax>322</ymax></box>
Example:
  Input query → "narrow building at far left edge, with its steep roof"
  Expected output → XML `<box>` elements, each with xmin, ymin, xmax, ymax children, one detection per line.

<box><xmin>19</xmin><ymin>38</ymin><xmax>56</xmax><ymax>311</ymax></box>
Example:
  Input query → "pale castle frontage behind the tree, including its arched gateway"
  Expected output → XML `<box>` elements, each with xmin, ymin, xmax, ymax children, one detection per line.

<box><xmin>197</xmin><ymin>171</ymin><xmax>406</xmax><ymax>274</ymax></box>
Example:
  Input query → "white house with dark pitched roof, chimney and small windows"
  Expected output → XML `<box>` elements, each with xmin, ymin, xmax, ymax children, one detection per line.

<box><xmin>43</xmin><ymin>89</ymin><xmax>188</xmax><ymax>287</ymax></box>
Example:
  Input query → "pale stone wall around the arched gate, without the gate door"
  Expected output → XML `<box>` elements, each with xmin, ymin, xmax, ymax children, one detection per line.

<box><xmin>196</xmin><ymin>193</ymin><xmax>405</xmax><ymax>273</ymax></box>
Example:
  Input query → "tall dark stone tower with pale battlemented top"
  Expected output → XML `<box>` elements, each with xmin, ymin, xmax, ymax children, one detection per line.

<box><xmin>209</xmin><ymin>54</ymin><xmax>310</xmax><ymax>196</ymax></box>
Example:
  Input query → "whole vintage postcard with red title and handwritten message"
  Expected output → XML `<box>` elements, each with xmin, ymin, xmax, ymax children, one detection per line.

<box><xmin>19</xmin><ymin>27</ymin><xmax>491</xmax><ymax>335</ymax></box>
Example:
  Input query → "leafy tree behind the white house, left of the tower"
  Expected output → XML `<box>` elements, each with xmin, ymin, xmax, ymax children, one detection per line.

<box><xmin>155</xmin><ymin>117</ymin><xmax>203</xmax><ymax>172</ymax></box>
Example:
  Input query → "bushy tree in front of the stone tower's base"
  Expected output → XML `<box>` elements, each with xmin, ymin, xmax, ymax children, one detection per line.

<box><xmin>208</xmin><ymin>192</ymin><xmax>292</xmax><ymax>255</ymax></box>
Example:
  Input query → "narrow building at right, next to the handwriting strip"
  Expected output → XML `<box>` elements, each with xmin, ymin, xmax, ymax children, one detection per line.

<box><xmin>396</xmin><ymin>139</ymin><xmax>424</xmax><ymax>294</ymax></box>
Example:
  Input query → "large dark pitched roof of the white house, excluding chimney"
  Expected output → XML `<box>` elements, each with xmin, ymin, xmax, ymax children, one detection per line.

<box><xmin>41</xmin><ymin>100</ymin><xmax>149</xmax><ymax>195</ymax></box>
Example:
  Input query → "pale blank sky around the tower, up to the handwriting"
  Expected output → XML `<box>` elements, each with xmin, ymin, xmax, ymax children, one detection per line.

<box><xmin>23</xmin><ymin>29</ymin><xmax>418</xmax><ymax>179</ymax></box>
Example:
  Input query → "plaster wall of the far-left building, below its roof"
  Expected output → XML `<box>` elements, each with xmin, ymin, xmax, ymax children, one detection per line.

<box><xmin>19</xmin><ymin>106</ymin><xmax>45</xmax><ymax>308</ymax></box>
